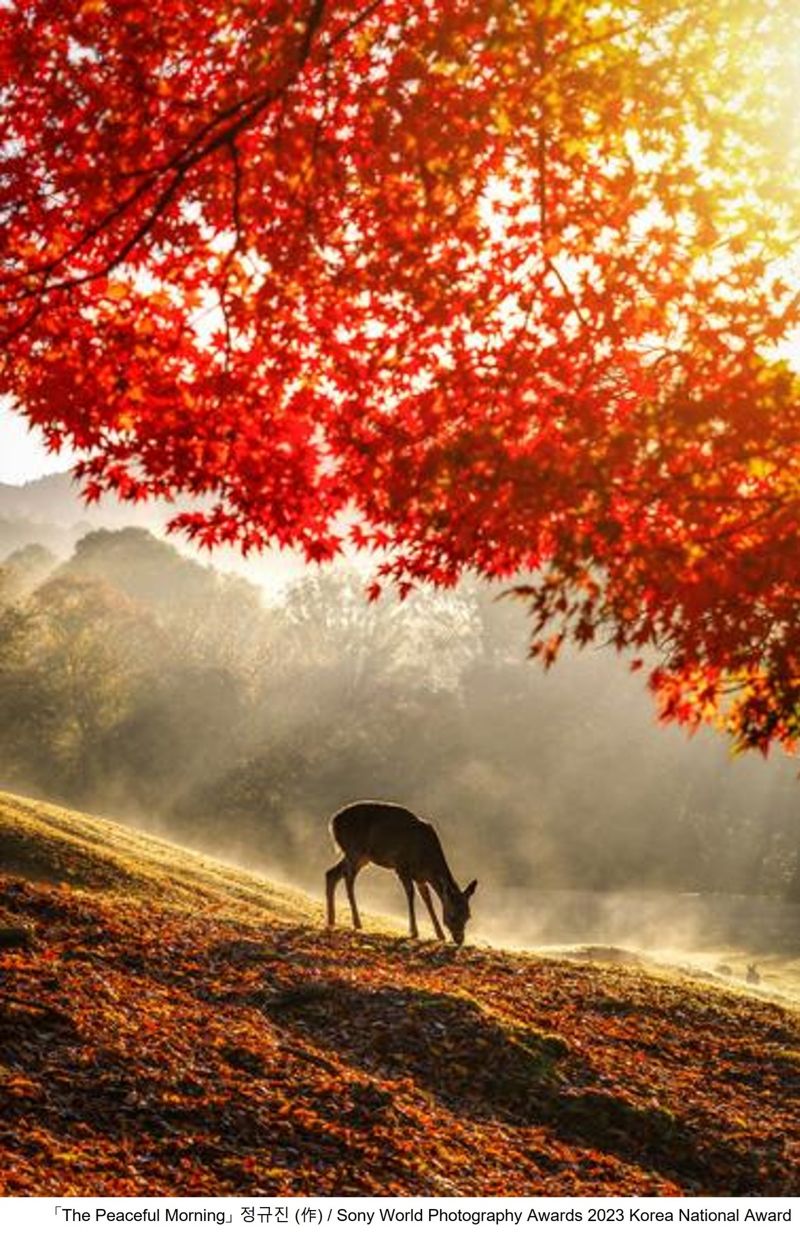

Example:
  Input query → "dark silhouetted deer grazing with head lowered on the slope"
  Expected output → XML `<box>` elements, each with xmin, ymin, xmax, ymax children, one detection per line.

<box><xmin>325</xmin><ymin>802</ymin><xmax>478</xmax><ymax>944</ymax></box>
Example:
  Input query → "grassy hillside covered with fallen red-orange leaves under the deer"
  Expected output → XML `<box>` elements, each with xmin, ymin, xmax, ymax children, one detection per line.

<box><xmin>0</xmin><ymin>794</ymin><xmax>800</xmax><ymax>1195</ymax></box>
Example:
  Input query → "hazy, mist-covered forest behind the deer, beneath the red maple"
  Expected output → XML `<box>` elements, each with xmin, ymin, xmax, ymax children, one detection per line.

<box><xmin>0</xmin><ymin>482</ymin><xmax>800</xmax><ymax>918</ymax></box>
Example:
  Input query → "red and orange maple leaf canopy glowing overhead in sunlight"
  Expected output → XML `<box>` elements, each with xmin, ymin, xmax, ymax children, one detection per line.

<box><xmin>0</xmin><ymin>0</ymin><xmax>800</xmax><ymax>750</ymax></box>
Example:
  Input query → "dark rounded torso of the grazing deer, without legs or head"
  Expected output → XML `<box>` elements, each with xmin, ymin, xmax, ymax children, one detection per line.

<box><xmin>331</xmin><ymin>802</ymin><xmax>441</xmax><ymax>874</ymax></box>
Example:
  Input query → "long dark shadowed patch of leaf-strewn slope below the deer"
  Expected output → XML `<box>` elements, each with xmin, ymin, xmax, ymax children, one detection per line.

<box><xmin>265</xmin><ymin>982</ymin><xmax>763</xmax><ymax>1194</ymax></box>
